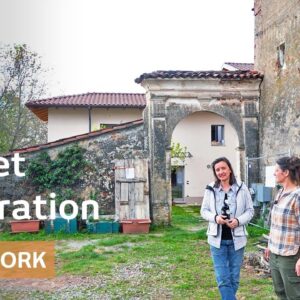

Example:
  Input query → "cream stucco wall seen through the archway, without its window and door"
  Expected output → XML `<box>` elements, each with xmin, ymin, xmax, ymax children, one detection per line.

<box><xmin>172</xmin><ymin>112</ymin><xmax>240</xmax><ymax>197</ymax></box>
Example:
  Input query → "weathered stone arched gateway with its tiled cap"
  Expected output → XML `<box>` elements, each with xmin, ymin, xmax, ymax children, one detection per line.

<box><xmin>136</xmin><ymin>71</ymin><xmax>263</xmax><ymax>224</ymax></box>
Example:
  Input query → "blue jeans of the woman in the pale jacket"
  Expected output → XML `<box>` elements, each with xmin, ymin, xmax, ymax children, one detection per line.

<box><xmin>210</xmin><ymin>240</ymin><xmax>244</xmax><ymax>300</ymax></box>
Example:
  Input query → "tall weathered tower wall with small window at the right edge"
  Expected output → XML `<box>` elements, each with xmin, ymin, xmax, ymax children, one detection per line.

<box><xmin>254</xmin><ymin>0</ymin><xmax>300</xmax><ymax>165</ymax></box>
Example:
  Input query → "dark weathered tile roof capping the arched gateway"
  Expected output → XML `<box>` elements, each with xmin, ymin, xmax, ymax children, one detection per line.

<box><xmin>135</xmin><ymin>70</ymin><xmax>263</xmax><ymax>83</ymax></box>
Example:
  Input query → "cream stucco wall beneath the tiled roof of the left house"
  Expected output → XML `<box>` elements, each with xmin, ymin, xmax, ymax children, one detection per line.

<box><xmin>48</xmin><ymin>108</ymin><xmax>143</xmax><ymax>142</ymax></box>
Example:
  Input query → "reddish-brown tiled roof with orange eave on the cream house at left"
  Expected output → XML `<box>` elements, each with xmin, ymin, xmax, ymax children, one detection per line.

<box><xmin>26</xmin><ymin>93</ymin><xmax>146</xmax><ymax>121</ymax></box>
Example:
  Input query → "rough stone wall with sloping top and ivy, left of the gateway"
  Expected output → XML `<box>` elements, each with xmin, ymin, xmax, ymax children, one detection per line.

<box><xmin>0</xmin><ymin>120</ymin><xmax>149</xmax><ymax>229</ymax></box>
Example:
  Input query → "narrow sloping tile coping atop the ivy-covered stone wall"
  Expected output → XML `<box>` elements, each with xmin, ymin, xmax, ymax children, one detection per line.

<box><xmin>6</xmin><ymin>119</ymin><xmax>144</xmax><ymax>157</ymax></box>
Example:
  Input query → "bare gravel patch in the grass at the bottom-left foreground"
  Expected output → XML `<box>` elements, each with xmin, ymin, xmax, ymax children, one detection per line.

<box><xmin>0</xmin><ymin>262</ymin><xmax>171</xmax><ymax>300</ymax></box>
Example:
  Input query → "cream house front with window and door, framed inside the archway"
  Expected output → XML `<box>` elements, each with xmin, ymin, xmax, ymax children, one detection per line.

<box><xmin>171</xmin><ymin>111</ymin><xmax>241</xmax><ymax>204</ymax></box>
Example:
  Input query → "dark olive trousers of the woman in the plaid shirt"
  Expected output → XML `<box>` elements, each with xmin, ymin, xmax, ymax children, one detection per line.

<box><xmin>270</xmin><ymin>252</ymin><xmax>300</xmax><ymax>300</ymax></box>
